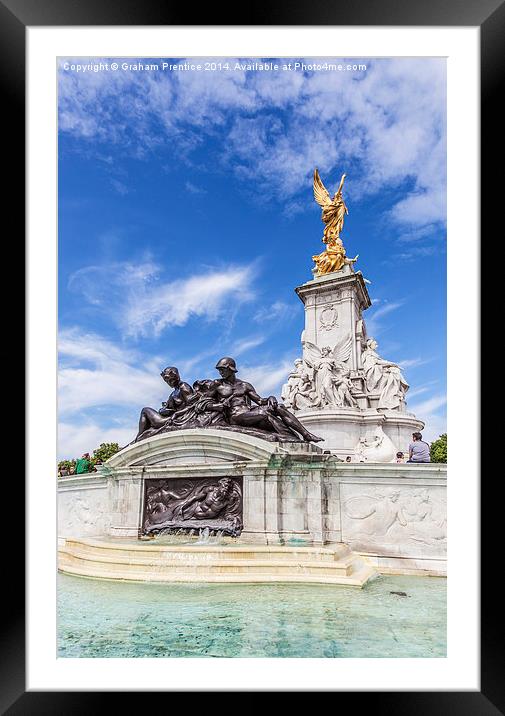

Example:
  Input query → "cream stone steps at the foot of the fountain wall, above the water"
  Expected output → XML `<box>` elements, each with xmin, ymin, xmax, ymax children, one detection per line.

<box><xmin>59</xmin><ymin>539</ymin><xmax>376</xmax><ymax>587</ymax></box>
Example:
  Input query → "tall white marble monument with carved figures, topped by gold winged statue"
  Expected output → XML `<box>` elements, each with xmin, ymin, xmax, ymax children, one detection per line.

<box><xmin>281</xmin><ymin>170</ymin><xmax>424</xmax><ymax>462</ymax></box>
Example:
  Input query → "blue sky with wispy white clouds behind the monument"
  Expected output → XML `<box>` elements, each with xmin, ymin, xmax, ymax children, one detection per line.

<box><xmin>59</xmin><ymin>58</ymin><xmax>446</xmax><ymax>457</ymax></box>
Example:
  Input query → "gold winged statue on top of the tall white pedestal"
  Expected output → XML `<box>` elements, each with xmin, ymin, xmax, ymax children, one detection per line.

<box><xmin>312</xmin><ymin>169</ymin><xmax>358</xmax><ymax>276</ymax></box>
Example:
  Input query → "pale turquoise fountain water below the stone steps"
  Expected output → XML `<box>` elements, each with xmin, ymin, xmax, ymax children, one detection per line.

<box><xmin>58</xmin><ymin>574</ymin><xmax>446</xmax><ymax>658</ymax></box>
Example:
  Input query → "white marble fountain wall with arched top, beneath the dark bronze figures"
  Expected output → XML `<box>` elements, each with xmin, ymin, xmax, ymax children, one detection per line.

<box><xmin>58</xmin><ymin>430</ymin><xmax>446</xmax><ymax>581</ymax></box>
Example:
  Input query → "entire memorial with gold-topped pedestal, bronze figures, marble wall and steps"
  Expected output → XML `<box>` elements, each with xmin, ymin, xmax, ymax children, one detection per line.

<box><xmin>58</xmin><ymin>170</ymin><xmax>446</xmax><ymax>587</ymax></box>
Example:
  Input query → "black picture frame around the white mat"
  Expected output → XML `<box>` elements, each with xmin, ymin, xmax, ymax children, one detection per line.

<box><xmin>5</xmin><ymin>0</ymin><xmax>496</xmax><ymax>716</ymax></box>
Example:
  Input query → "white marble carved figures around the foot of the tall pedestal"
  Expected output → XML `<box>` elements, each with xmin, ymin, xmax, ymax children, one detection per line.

<box><xmin>281</xmin><ymin>336</ymin><xmax>409</xmax><ymax>411</ymax></box>
